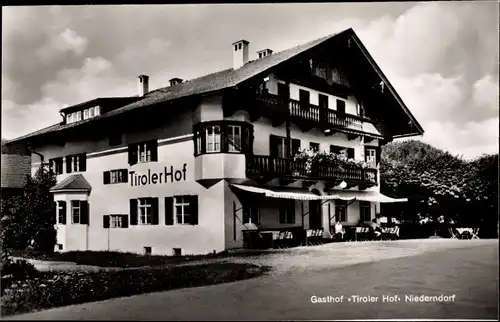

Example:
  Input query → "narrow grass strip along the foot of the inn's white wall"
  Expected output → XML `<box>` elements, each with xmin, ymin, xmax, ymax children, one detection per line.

<box><xmin>8</xmin><ymin>251</ymin><xmax>282</xmax><ymax>268</ymax></box>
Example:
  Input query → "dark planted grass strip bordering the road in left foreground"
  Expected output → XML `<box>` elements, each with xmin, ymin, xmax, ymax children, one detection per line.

<box><xmin>1</xmin><ymin>257</ymin><xmax>269</xmax><ymax>316</ymax></box>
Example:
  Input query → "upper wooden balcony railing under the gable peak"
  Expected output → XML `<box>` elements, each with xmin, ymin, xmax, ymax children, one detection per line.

<box><xmin>255</xmin><ymin>94</ymin><xmax>375</xmax><ymax>130</ymax></box>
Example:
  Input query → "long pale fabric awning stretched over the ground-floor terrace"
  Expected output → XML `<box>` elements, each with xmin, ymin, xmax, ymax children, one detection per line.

<box><xmin>231</xmin><ymin>184</ymin><xmax>408</xmax><ymax>203</ymax></box>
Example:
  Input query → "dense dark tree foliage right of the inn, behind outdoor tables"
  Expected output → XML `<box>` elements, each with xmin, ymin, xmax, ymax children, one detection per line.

<box><xmin>380</xmin><ymin>141</ymin><xmax>498</xmax><ymax>238</ymax></box>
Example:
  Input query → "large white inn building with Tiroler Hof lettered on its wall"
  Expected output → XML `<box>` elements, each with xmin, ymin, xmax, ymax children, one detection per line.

<box><xmin>8</xmin><ymin>29</ymin><xmax>423</xmax><ymax>254</ymax></box>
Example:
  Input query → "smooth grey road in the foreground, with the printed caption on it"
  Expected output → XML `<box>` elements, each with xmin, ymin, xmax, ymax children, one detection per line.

<box><xmin>5</xmin><ymin>240</ymin><xmax>498</xmax><ymax>320</ymax></box>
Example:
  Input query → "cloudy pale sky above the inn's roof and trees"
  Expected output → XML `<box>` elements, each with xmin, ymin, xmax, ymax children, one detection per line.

<box><xmin>2</xmin><ymin>1</ymin><xmax>499</xmax><ymax>158</ymax></box>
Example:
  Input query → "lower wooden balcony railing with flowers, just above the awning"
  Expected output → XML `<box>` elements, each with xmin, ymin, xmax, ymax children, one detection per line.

<box><xmin>246</xmin><ymin>155</ymin><xmax>377</xmax><ymax>186</ymax></box>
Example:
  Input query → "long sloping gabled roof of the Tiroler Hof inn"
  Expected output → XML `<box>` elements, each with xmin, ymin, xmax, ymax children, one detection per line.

<box><xmin>9</xmin><ymin>28</ymin><xmax>423</xmax><ymax>142</ymax></box>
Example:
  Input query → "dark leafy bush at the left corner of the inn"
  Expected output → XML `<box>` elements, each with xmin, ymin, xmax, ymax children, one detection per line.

<box><xmin>1</xmin><ymin>167</ymin><xmax>56</xmax><ymax>251</ymax></box>
